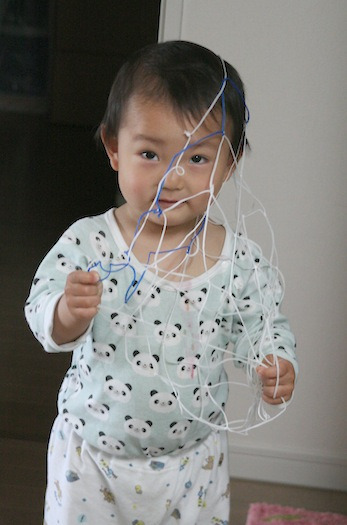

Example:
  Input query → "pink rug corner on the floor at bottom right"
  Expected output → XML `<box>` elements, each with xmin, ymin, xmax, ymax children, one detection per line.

<box><xmin>246</xmin><ymin>503</ymin><xmax>347</xmax><ymax>525</ymax></box>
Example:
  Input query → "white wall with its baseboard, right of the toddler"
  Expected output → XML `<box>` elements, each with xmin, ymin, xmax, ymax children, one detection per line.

<box><xmin>160</xmin><ymin>0</ymin><xmax>347</xmax><ymax>490</ymax></box>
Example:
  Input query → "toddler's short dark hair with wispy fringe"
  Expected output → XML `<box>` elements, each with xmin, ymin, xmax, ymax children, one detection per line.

<box><xmin>97</xmin><ymin>40</ymin><xmax>248</xmax><ymax>154</ymax></box>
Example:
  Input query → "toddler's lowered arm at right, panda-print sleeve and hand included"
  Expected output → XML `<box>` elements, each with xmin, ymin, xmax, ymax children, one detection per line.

<box><xmin>231</xmin><ymin>237</ymin><xmax>298</xmax><ymax>405</ymax></box>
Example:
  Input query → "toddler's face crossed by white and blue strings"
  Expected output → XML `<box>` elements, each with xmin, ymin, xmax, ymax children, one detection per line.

<box><xmin>106</xmin><ymin>96</ymin><xmax>232</xmax><ymax>231</ymax></box>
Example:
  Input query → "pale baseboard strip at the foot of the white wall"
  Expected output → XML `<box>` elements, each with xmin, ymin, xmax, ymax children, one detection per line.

<box><xmin>229</xmin><ymin>443</ymin><xmax>347</xmax><ymax>491</ymax></box>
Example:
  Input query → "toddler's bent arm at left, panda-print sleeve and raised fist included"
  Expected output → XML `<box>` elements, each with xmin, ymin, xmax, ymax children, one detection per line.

<box><xmin>25</xmin><ymin>217</ymin><xmax>105</xmax><ymax>353</ymax></box>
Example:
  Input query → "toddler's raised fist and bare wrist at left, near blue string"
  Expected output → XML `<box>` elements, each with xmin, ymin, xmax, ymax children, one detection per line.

<box><xmin>52</xmin><ymin>270</ymin><xmax>102</xmax><ymax>345</ymax></box>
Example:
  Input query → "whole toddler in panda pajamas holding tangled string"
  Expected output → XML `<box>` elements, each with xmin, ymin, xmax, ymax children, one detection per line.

<box><xmin>25</xmin><ymin>41</ymin><xmax>297</xmax><ymax>525</ymax></box>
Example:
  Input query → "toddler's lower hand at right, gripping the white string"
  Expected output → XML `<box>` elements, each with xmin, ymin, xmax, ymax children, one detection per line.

<box><xmin>257</xmin><ymin>354</ymin><xmax>295</xmax><ymax>405</ymax></box>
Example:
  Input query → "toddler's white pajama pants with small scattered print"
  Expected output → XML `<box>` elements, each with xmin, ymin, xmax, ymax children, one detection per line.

<box><xmin>44</xmin><ymin>416</ymin><xmax>230</xmax><ymax>525</ymax></box>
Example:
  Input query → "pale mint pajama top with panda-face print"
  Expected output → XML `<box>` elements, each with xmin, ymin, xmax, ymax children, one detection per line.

<box><xmin>25</xmin><ymin>209</ymin><xmax>297</xmax><ymax>457</ymax></box>
